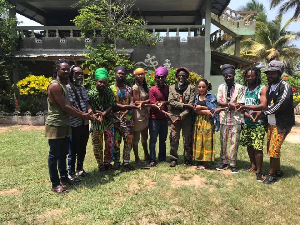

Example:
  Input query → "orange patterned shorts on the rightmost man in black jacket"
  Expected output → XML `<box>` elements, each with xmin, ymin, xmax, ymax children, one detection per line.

<box><xmin>267</xmin><ymin>125</ymin><xmax>289</xmax><ymax>158</ymax></box>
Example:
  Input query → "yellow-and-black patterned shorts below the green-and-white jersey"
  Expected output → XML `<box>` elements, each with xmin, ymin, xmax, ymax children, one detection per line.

<box><xmin>240</xmin><ymin>125</ymin><xmax>266</xmax><ymax>151</ymax></box>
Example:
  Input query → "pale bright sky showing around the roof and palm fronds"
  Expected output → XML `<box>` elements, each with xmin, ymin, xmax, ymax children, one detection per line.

<box><xmin>17</xmin><ymin>0</ymin><xmax>300</xmax><ymax>48</ymax></box>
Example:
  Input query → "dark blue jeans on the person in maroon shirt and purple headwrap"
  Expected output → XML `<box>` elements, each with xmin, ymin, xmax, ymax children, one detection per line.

<box><xmin>149</xmin><ymin>119</ymin><xmax>168</xmax><ymax>162</ymax></box>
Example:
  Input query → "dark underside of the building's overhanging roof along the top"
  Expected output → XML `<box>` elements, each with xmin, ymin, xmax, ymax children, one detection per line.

<box><xmin>7</xmin><ymin>0</ymin><xmax>230</xmax><ymax>26</ymax></box>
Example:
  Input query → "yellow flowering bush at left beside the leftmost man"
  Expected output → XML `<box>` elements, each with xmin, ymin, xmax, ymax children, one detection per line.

<box><xmin>17</xmin><ymin>75</ymin><xmax>52</xmax><ymax>96</ymax></box>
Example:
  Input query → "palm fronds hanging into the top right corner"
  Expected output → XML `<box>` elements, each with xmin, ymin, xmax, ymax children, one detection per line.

<box><xmin>270</xmin><ymin>0</ymin><xmax>300</xmax><ymax>19</ymax></box>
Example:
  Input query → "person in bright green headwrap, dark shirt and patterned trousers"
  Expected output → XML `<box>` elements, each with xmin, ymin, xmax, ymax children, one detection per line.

<box><xmin>88</xmin><ymin>68</ymin><xmax>115</xmax><ymax>171</ymax></box>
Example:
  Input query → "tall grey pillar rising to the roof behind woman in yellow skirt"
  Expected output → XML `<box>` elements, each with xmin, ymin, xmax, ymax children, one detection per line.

<box><xmin>204</xmin><ymin>0</ymin><xmax>211</xmax><ymax>80</ymax></box>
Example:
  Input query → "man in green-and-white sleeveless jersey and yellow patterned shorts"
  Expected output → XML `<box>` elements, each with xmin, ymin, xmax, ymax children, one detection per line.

<box><xmin>237</xmin><ymin>67</ymin><xmax>267</xmax><ymax>182</ymax></box>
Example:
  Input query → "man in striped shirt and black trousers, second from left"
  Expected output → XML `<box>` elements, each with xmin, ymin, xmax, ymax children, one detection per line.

<box><xmin>66</xmin><ymin>65</ymin><xmax>91</xmax><ymax>182</ymax></box>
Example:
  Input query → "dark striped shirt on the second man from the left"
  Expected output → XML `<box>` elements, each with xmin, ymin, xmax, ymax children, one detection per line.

<box><xmin>66</xmin><ymin>84</ymin><xmax>90</xmax><ymax>127</ymax></box>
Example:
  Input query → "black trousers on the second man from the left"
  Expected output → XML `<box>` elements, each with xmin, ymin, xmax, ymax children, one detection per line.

<box><xmin>68</xmin><ymin>125</ymin><xmax>89</xmax><ymax>174</ymax></box>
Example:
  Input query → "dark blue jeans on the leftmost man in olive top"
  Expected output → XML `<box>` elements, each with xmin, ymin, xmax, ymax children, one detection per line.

<box><xmin>48</xmin><ymin>137</ymin><xmax>70</xmax><ymax>187</ymax></box>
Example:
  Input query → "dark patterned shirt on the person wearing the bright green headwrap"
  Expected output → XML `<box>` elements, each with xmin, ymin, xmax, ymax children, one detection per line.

<box><xmin>88</xmin><ymin>88</ymin><xmax>115</xmax><ymax>133</ymax></box>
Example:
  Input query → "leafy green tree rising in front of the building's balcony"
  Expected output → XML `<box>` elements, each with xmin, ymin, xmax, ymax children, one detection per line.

<box><xmin>74</xmin><ymin>0</ymin><xmax>156</xmax><ymax>88</ymax></box>
